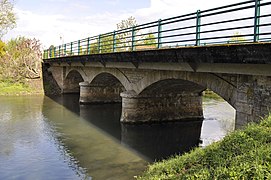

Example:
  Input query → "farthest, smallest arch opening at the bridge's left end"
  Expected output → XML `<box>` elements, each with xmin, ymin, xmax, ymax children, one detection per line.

<box><xmin>63</xmin><ymin>70</ymin><xmax>84</xmax><ymax>93</ymax></box>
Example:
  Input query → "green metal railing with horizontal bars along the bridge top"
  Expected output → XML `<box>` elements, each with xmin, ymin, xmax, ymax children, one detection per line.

<box><xmin>43</xmin><ymin>0</ymin><xmax>271</xmax><ymax>59</ymax></box>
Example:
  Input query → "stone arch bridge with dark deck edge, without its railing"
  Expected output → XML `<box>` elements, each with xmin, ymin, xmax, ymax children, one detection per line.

<box><xmin>43</xmin><ymin>43</ymin><xmax>271</xmax><ymax>128</ymax></box>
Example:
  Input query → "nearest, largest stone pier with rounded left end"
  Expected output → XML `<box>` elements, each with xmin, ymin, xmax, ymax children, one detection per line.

<box><xmin>121</xmin><ymin>91</ymin><xmax>203</xmax><ymax>123</ymax></box>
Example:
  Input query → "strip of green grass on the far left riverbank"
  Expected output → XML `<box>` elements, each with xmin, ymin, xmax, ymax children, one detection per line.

<box><xmin>0</xmin><ymin>82</ymin><xmax>32</xmax><ymax>95</ymax></box>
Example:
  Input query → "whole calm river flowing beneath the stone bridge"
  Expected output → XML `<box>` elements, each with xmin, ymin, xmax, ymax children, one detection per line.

<box><xmin>0</xmin><ymin>95</ymin><xmax>235</xmax><ymax>180</ymax></box>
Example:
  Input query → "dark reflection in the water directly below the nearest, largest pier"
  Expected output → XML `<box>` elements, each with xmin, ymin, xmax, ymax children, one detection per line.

<box><xmin>121</xmin><ymin>121</ymin><xmax>202</xmax><ymax>161</ymax></box>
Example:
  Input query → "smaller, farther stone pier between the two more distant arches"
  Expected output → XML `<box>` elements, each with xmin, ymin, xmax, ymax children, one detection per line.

<box><xmin>79</xmin><ymin>82</ymin><xmax>122</xmax><ymax>104</ymax></box>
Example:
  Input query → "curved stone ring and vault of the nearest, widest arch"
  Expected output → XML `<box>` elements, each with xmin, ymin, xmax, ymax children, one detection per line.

<box><xmin>137</xmin><ymin>72</ymin><xmax>237</xmax><ymax>108</ymax></box>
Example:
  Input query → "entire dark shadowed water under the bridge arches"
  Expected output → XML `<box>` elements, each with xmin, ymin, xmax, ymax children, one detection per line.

<box><xmin>52</xmin><ymin>95</ymin><xmax>202</xmax><ymax>161</ymax></box>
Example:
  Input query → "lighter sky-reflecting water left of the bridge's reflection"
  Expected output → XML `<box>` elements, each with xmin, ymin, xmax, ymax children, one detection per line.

<box><xmin>0</xmin><ymin>96</ymin><xmax>88</xmax><ymax>179</ymax></box>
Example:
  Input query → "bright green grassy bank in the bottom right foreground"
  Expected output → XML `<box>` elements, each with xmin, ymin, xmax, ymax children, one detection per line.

<box><xmin>138</xmin><ymin>116</ymin><xmax>271</xmax><ymax>180</ymax></box>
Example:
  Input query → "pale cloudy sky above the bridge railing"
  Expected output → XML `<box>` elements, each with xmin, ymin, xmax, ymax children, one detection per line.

<box><xmin>4</xmin><ymin>0</ymin><xmax>241</xmax><ymax>48</ymax></box>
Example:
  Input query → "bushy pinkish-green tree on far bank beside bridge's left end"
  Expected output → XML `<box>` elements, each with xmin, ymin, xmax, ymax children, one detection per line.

<box><xmin>0</xmin><ymin>37</ymin><xmax>42</xmax><ymax>82</ymax></box>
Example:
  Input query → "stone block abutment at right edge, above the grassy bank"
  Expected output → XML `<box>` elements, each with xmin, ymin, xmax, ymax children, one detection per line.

<box><xmin>235</xmin><ymin>75</ymin><xmax>271</xmax><ymax>129</ymax></box>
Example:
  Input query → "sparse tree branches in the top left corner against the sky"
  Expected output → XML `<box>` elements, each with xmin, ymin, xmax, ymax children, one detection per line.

<box><xmin>0</xmin><ymin>0</ymin><xmax>16</xmax><ymax>39</ymax></box>
